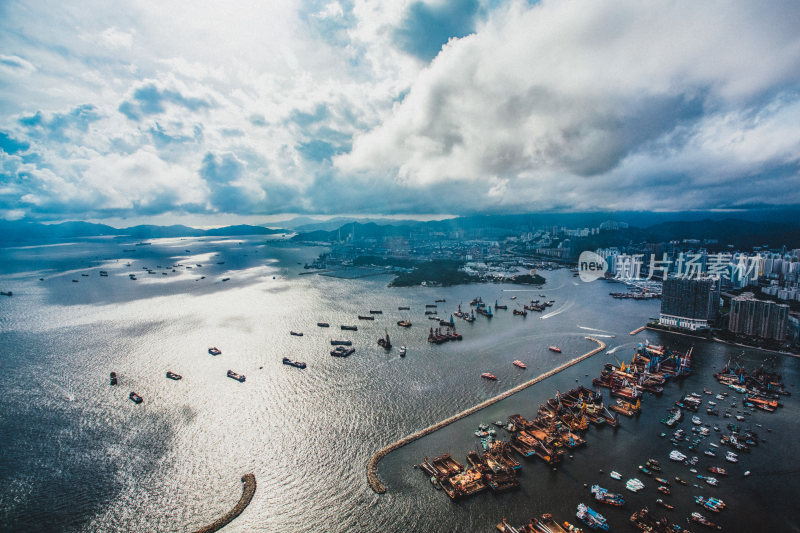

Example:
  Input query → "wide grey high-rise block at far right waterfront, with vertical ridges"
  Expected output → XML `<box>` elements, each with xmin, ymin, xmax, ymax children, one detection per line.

<box><xmin>728</xmin><ymin>292</ymin><xmax>789</xmax><ymax>342</ymax></box>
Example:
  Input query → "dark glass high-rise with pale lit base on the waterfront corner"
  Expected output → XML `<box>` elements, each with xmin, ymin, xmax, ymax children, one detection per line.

<box><xmin>658</xmin><ymin>278</ymin><xmax>719</xmax><ymax>331</ymax></box>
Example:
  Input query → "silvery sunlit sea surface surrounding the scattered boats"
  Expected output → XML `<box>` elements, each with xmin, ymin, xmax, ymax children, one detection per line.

<box><xmin>0</xmin><ymin>238</ymin><xmax>800</xmax><ymax>532</ymax></box>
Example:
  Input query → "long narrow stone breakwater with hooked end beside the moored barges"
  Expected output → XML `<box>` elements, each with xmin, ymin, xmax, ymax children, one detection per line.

<box><xmin>367</xmin><ymin>337</ymin><xmax>606</xmax><ymax>494</ymax></box>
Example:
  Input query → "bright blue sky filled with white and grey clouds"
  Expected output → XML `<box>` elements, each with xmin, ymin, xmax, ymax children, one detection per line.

<box><xmin>0</xmin><ymin>0</ymin><xmax>800</xmax><ymax>221</ymax></box>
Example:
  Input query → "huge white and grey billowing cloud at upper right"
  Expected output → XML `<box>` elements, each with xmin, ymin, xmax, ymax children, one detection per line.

<box><xmin>337</xmin><ymin>1</ymin><xmax>800</xmax><ymax>208</ymax></box>
